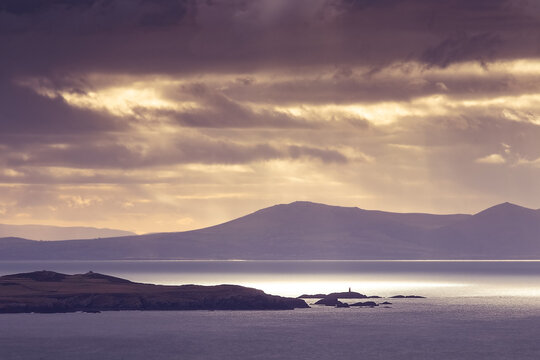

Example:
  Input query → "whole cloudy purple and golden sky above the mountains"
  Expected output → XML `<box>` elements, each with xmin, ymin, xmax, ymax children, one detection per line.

<box><xmin>0</xmin><ymin>0</ymin><xmax>540</xmax><ymax>233</ymax></box>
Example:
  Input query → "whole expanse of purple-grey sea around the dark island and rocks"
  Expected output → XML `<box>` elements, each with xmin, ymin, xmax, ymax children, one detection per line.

<box><xmin>0</xmin><ymin>260</ymin><xmax>540</xmax><ymax>360</ymax></box>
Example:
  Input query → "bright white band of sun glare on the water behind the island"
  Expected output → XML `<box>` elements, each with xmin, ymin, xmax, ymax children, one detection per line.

<box><xmin>121</xmin><ymin>273</ymin><xmax>528</xmax><ymax>297</ymax></box>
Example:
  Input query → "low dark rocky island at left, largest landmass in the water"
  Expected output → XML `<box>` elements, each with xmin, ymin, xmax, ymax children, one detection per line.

<box><xmin>0</xmin><ymin>271</ymin><xmax>309</xmax><ymax>313</ymax></box>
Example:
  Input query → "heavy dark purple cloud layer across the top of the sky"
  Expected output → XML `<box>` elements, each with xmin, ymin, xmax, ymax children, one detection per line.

<box><xmin>0</xmin><ymin>0</ymin><xmax>540</xmax><ymax>75</ymax></box>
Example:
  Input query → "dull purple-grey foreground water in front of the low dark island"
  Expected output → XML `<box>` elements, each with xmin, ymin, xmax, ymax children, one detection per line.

<box><xmin>0</xmin><ymin>298</ymin><xmax>540</xmax><ymax>360</ymax></box>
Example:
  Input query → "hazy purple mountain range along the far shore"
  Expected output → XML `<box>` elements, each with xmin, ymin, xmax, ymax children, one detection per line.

<box><xmin>0</xmin><ymin>201</ymin><xmax>540</xmax><ymax>260</ymax></box>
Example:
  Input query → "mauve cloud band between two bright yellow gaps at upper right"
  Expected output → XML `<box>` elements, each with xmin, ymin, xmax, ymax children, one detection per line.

<box><xmin>217</xmin><ymin>70</ymin><xmax>540</xmax><ymax>105</ymax></box>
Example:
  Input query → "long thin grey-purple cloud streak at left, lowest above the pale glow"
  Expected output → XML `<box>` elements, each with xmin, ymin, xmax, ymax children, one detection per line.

<box><xmin>0</xmin><ymin>138</ymin><xmax>347</xmax><ymax>169</ymax></box>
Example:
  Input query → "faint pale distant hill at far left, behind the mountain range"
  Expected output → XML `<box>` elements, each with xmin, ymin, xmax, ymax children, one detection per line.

<box><xmin>0</xmin><ymin>224</ymin><xmax>135</xmax><ymax>241</ymax></box>
